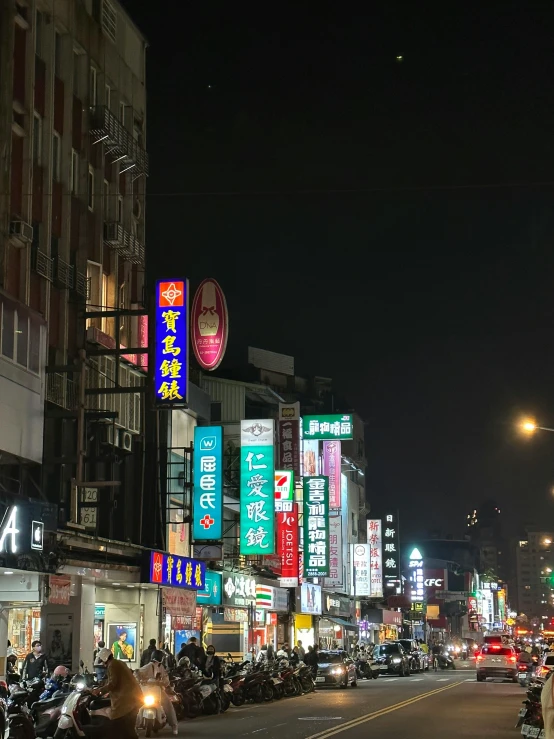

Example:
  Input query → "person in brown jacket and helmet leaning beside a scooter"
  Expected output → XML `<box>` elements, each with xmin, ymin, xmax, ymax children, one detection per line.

<box><xmin>92</xmin><ymin>647</ymin><xmax>142</xmax><ymax>739</ymax></box>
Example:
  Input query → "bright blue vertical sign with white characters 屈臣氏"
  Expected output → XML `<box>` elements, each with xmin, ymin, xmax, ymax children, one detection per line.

<box><xmin>192</xmin><ymin>426</ymin><xmax>223</xmax><ymax>541</ymax></box>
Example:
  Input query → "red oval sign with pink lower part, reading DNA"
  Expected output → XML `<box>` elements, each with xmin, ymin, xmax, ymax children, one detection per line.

<box><xmin>190</xmin><ymin>279</ymin><xmax>225</xmax><ymax>370</ymax></box>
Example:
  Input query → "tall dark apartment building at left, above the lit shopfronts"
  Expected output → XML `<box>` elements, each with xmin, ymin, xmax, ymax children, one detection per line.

<box><xmin>0</xmin><ymin>0</ymin><xmax>148</xmax><ymax>541</ymax></box>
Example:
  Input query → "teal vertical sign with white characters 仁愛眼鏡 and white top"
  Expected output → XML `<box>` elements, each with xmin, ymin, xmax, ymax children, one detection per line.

<box><xmin>240</xmin><ymin>419</ymin><xmax>275</xmax><ymax>555</ymax></box>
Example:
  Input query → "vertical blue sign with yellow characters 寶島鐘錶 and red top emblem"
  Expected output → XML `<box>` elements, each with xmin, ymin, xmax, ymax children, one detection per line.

<box><xmin>154</xmin><ymin>280</ymin><xmax>188</xmax><ymax>405</ymax></box>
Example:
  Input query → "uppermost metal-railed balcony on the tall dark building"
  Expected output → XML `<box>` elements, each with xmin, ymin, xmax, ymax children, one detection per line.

<box><xmin>90</xmin><ymin>105</ymin><xmax>148</xmax><ymax>178</ymax></box>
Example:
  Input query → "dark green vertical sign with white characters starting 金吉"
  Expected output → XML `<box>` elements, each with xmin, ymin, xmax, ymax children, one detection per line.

<box><xmin>304</xmin><ymin>475</ymin><xmax>329</xmax><ymax>577</ymax></box>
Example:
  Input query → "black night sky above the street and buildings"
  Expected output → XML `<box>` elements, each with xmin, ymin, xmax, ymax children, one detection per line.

<box><xmin>127</xmin><ymin>0</ymin><xmax>554</xmax><ymax>535</ymax></box>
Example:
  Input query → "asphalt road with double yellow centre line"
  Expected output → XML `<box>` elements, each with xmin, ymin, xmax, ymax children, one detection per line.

<box><xmin>154</xmin><ymin>670</ymin><xmax>525</xmax><ymax>739</ymax></box>
